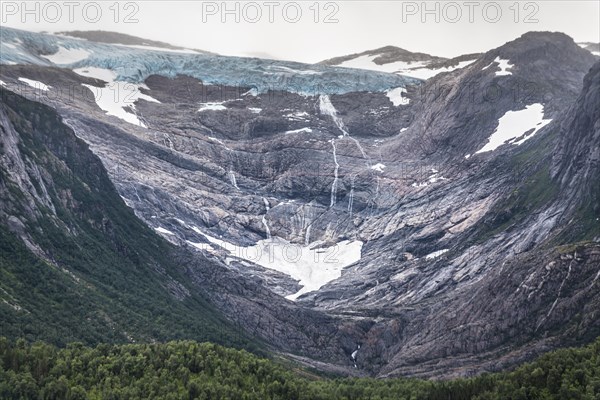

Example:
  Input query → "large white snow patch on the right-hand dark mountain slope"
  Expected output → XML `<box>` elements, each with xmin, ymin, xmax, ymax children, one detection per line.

<box><xmin>475</xmin><ymin>103</ymin><xmax>552</xmax><ymax>154</ymax></box>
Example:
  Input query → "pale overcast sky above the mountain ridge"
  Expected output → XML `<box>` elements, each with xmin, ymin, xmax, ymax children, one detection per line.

<box><xmin>1</xmin><ymin>0</ymin><xmax>600</xmax><ymax>62</ymax></box>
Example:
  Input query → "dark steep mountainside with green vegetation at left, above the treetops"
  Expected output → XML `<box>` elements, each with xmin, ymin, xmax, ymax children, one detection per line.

<box><xmin>0</xmin><ymin>89</ymin><xmax>256</xmax><ymax>349</ymax></box>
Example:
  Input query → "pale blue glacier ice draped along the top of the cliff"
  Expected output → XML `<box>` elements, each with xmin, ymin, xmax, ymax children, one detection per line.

<box><xmin>0</xmin><ymin>27</ymin><xmax>421</xmax><ymax>95</ymax></box>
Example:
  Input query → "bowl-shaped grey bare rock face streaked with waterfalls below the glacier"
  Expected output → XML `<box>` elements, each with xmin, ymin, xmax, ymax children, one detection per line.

<box><xmin>0</xmin><ymin>28</ymin><xmax>600</xmax><ymax>377</ymax></box>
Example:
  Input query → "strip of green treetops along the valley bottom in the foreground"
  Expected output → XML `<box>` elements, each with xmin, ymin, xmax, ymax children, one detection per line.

<box><xmin>0</xmin><ymin>338</ymin><xmax>600</xmax><ymax>400</ymax></box>
